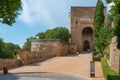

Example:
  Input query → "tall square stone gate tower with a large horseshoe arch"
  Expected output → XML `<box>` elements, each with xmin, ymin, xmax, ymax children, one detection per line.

<box><xmin>70</xmin><ymin>7</ymin><xmax>106</xmax><ymax>52</ymax></box>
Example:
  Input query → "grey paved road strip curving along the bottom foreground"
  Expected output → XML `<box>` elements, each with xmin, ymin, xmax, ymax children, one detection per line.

<box><xmin>0</xmin><ymin>73</ymin><xmax>87</xmax><ymax>80</ymax></box>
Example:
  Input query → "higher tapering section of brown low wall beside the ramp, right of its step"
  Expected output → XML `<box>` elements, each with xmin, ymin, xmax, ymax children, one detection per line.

<box><xmin>17</xmin><ymin>50</ymin><xmax>55</xmax><ymax>65</ymax></box>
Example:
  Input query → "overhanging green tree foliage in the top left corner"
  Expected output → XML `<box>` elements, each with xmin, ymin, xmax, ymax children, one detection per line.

<box><xmin>0</xmin><ymin>0</ymin><xmax>22</xmax><ymax>25</ymax></box>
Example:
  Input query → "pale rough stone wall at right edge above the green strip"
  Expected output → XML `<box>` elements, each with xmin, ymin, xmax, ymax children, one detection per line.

<box><xmin>110</xmin><ymin>37</ymin><xmax>120</xmax><ymax>73</ymax></box>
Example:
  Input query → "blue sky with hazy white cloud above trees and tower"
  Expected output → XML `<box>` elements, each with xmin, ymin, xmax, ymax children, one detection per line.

<box><xmin>0</xmin><ymin>0</ymin><xmax>108</xmax><ymax>47</ymax></box>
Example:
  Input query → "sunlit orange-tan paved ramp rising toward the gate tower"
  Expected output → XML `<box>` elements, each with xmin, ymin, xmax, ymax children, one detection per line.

<box><xmin>9</xmin><ymin>53</ymin><xmax>104</xmax><ymax>80</ymax></box>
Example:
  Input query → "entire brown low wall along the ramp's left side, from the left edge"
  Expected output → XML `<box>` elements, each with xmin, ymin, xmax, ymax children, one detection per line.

<box><xmin>0</xmin><ymin>50</ymin><xmax>55</xmax><ymax>70</ymax></box>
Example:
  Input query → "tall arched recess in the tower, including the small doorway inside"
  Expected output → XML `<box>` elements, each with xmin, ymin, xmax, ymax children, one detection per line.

<box><xmin>82</xmin><ymin>27</ymin><xmax>93</xmax><ymax>51</ymax></box>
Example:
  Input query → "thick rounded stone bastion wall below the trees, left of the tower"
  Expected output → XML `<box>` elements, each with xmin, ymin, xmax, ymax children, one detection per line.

<box><xmin>31</xmin><ymin>39</ymin><xmax>69</xmax><ymax>56</ymax></box>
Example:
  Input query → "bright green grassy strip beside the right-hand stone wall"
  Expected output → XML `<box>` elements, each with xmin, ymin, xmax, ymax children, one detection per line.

<box><xmin>101</xmin><ymin>58</ymin><xmax>120</xmax><ymax>80</ymax></box>
